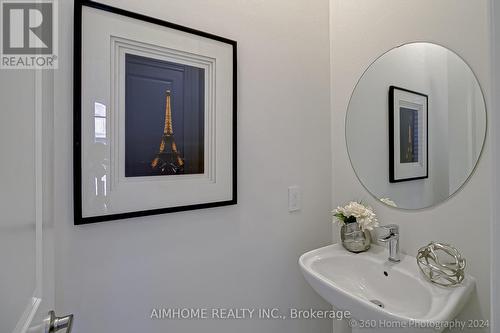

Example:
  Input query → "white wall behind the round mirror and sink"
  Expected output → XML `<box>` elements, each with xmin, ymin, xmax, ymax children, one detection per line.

<box><xmin>330</xmin><ymin>0</ymin><xmax>491</xmax><ymax>332</ymax></box>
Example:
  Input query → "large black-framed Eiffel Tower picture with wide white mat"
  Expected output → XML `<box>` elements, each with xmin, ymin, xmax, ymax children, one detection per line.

<box><xmin>74</xmin><ymin>0</ymin><xmax>237</xmax><ymax>224</ymax></box>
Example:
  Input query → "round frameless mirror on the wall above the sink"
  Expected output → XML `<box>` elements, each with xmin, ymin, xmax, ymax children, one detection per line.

<box><xmin>346</xmin><ymin>43</ymin><xmax>486</xmax><ymax>209</ymax></box>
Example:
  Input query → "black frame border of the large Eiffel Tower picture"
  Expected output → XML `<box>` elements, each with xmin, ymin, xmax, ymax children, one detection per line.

<box><xmin>73</xmin><ymin>0</ymin><xmax>238</xmax><ymax>225</ymax></box>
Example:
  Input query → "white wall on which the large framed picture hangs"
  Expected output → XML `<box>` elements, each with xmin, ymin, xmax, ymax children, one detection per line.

<box><xmin>55</xmin><ymin>0</ymin><xmax>332</xmax><ymax>333</ymax></box>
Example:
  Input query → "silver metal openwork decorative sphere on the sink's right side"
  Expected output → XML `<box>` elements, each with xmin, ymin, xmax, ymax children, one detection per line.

<box><xmin>417</xmin><ymin>242</ymin><xmax>466</xmax><ymax>287</ymax></box>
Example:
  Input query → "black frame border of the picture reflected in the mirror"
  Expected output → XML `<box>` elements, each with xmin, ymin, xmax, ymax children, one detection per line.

<box><xmin>389</xmin><ymin>86</ymin><xmax>429</xmax><ymax>183</ymax></box>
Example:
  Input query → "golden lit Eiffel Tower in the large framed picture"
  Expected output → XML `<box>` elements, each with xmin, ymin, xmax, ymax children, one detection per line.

<box><xmin>151</xmin><ymin>90</ymin><xmax>184</xmax><ymax>175</ymax></box>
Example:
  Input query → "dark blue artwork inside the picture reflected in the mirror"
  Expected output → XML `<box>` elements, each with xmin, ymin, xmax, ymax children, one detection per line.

<box><xmin>399</xmin><ymin>108</ymin><xmax>419</xmax><ymax>163</ymax></box>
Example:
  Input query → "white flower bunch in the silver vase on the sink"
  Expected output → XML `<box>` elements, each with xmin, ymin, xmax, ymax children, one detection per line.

<box><xmin>332</xmin><ymin>201</ymin><xmax>378</xmax><ymax>231</ymax></box>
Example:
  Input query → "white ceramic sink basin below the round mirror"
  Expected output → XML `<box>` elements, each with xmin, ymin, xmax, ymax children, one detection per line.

<box><xmin>299</xmin><ymin>244</ymin><xmax>475</xmax><ymax>332</ymax></box>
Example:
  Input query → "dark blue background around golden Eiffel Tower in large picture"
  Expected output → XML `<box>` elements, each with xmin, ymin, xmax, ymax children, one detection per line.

<box><xmin>125</xmin><ymin>54</ymin><xmax>205</xmax><ymax>177</ymax></box>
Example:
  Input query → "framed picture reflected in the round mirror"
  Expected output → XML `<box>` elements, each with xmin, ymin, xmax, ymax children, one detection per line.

<box><xmin>389</xmin><ymin>86</ymin><xmax>429</xmax><ymax>183</ymax></box>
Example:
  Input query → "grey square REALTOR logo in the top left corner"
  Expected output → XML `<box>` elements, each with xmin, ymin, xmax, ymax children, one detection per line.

<box><xmin>0</xmin><ymin>0</ymin><xmax>57</xmax><ymax>69</ymax></box>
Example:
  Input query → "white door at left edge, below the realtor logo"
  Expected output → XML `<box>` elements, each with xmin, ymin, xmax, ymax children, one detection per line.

<box><xmin>0</xmin><ymin>70</ymin><xmax>36</xmax><ymax>332</ymax></box>
